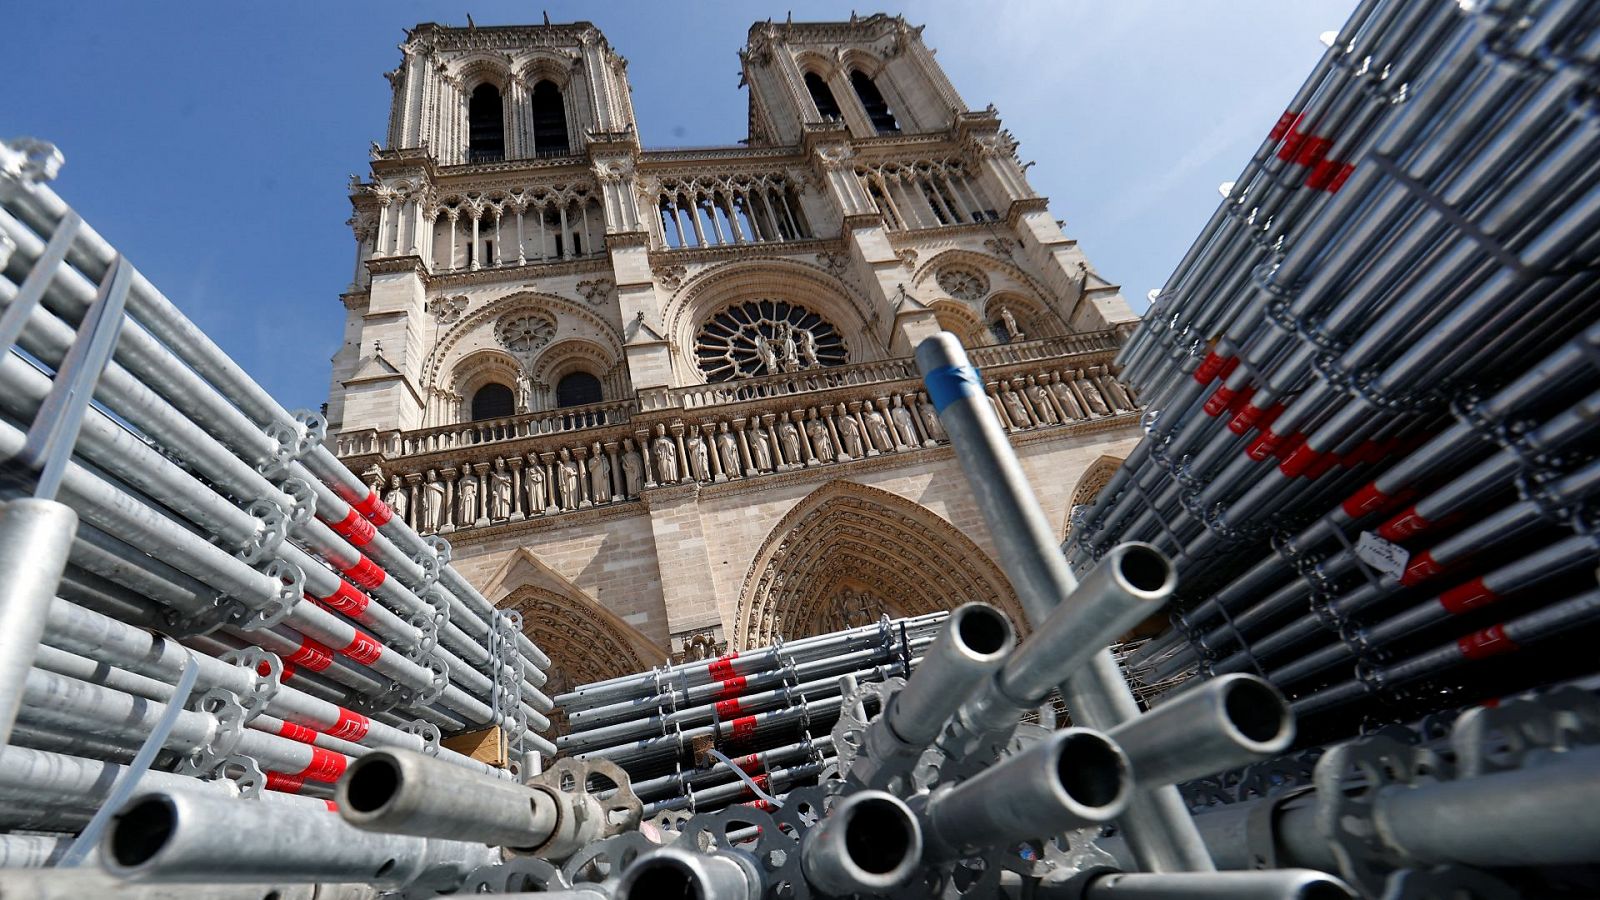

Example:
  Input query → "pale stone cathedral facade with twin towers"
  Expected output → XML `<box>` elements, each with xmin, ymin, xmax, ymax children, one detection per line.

<box><xmin>328</xmin><ymin>14</ymin><xmax>1139</xmax><ymax>701</ymax></box>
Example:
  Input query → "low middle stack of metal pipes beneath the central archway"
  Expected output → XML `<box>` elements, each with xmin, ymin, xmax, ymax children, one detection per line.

<box><xmin>555</xmin><ymin>612</ymin><xmax>949</xmax><ymax>817</ymax></box>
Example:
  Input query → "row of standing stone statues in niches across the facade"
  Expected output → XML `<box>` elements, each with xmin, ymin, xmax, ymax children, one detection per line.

<box><xmin>373</xmin><ymin>367</ymin><xmax>1136</xmax><ymax>533</ymax></box>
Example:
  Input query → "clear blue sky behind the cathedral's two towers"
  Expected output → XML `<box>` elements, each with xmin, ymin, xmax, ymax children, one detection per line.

<box><xmin>0</xmin><ymin>0</ymin><xmax>1354</xmax><ymax>408</ymax></box>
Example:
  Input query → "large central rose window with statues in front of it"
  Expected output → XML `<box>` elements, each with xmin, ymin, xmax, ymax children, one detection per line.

<box><xmin>694</xmin><ymin>299</ymin><xmax>848</xmax><ymax>381</ymax></box>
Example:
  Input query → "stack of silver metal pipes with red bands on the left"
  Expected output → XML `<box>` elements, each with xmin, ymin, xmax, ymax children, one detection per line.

<box><xmin>0</xmin><ymin>139</ymin><xmax>555</xmax><ymax>866</ymax></box>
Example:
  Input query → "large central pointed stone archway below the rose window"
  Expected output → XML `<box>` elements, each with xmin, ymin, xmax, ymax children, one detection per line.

<box><xmin>733</xmin><ymin>480</ymin><xmax>1026</xmax><ymax>649</ymax></box>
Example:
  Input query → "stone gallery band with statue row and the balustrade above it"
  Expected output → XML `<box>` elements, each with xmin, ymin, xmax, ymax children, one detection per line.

<box><xmin>339</xmin><ymin>335</ymin><xmax>1138</xmax><ymax>533</ymax></box>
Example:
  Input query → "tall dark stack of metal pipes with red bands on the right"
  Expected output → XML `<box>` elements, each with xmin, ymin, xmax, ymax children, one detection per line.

<box><xmin>1067</xmin><ymin>0</ymin><xmax>1600</xmax><ymax>723</ymax></box>
